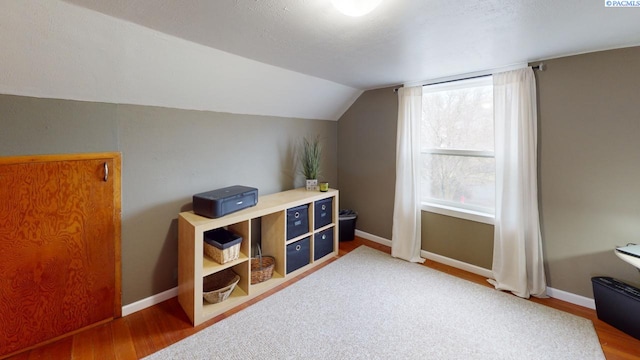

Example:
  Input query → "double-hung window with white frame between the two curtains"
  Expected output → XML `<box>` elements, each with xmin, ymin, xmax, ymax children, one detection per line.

<box><xmin>420</xmin><ymin>76</ymin><xmax>495</xmax><ymax>214</ymax></box>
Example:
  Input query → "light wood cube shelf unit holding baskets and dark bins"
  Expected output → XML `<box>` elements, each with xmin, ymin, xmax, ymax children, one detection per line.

<box><xmin>178</xmin><ymin>189</ymin><xmax>339</xmax><ymax>326</ymax></box>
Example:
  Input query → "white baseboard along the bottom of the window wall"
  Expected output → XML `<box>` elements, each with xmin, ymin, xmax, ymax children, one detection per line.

<box><xmin>356</xmin><ymin>230</ymin><xmax>596</xmax><ymax>309</ymax></box>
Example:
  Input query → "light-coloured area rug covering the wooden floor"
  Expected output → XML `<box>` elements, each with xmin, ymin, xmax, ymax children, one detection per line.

<box><xmin>147</xmin><ymin>246</ymin><xmax>604</xmax><ymax>360</ymax></box>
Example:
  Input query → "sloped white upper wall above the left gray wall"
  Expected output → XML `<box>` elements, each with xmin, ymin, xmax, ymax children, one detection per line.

<box><xmin>0</xmin><ymin>0</ymin><xmax>362</xmax><ymax>120</ymax></box>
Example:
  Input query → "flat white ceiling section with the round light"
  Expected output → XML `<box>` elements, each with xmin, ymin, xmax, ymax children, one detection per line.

<box><xmin>66</xmin><ymin>0</ymin><xmax>640</xmax><ymax>89</ymax></box>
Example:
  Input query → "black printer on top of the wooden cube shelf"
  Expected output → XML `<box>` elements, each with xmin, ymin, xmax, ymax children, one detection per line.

<box><xmin>193</xmin><ymin>185</ymin><xmax>258</xmax><ymax>219</ymax></box>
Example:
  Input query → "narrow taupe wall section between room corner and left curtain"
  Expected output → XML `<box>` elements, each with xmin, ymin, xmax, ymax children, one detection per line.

<box><xmin>338</xmin><ymin>88</ymin><xmax>398</xmax><ymax>239</ymax></box>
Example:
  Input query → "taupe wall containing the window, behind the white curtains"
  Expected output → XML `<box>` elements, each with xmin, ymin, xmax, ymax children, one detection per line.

<box><xmin>338</xmin><ymin>47</ymin><xmax>640</xmax><ymax>297</ymax></box>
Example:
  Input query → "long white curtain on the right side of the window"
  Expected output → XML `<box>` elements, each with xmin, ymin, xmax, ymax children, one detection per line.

<box><xmin>490</xmin><ymin>68</ymin><xmax>546</xmax><ymax>298</ymax></box>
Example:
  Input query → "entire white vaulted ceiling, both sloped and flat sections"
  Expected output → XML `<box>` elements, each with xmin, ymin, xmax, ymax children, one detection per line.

<box><xmin>0</xmin><ymin>0</ymin><xmax>640</xmax><ymax>120</ymax></box>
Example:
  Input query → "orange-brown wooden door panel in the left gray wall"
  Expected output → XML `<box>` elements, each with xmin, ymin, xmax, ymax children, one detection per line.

<box><xmin>0</xmin><ymin>154</ymin><xmax>120</xmax><ymax>356</ymax></box>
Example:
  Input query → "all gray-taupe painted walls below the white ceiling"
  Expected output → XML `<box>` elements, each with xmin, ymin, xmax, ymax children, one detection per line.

<box><xmin>5</xmin><ymin>47</ymin><xmax>640</xmax><ymax>304</ymax></box>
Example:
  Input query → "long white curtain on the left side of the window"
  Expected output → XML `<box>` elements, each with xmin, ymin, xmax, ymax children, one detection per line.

<box><xmin>391</xmin><ymin>86</ymin><xmax>424</xmax><ymax>262</ymax></box>
